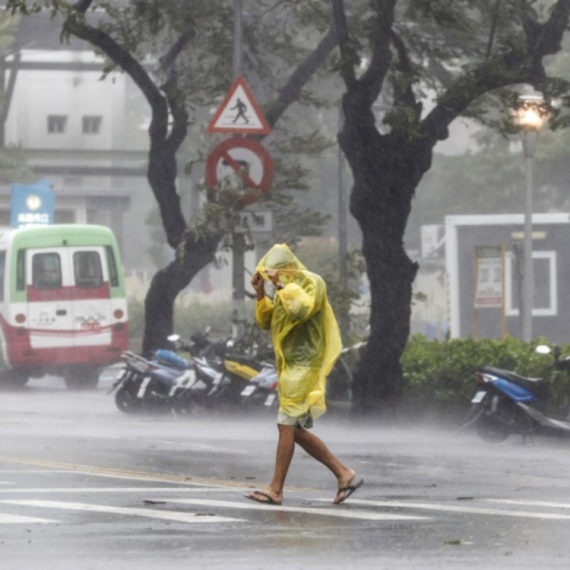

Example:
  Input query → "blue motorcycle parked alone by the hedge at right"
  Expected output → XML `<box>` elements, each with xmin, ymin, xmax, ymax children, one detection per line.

<box><xmin>466</xmin><ymin>345</ymin><xmax>570</xmax><ymax>443</ymax></box>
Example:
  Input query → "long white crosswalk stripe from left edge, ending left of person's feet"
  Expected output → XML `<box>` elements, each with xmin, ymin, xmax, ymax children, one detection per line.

<box><xmin>0</xmin><ymin>500</ymin><xmax>242</xmax><ymax>523</ymax></box>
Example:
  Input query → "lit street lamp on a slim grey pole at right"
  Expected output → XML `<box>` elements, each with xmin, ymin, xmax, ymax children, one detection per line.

<box><xmin>514</xmin><ymin>95</ymin><xmax>547</xmax><ymax>342</ymax></box>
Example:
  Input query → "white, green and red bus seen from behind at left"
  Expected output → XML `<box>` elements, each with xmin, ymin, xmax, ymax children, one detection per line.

<box><xmin>0</xmin><ymin>224</ymin><xmax>129</xmax><ymax>388</ymax></box>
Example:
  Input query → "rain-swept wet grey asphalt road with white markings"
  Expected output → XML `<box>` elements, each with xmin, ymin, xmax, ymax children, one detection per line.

<box><xmin>0</xmin><ymin>379</ymin><xmax>570</xmax><ymax>570</ymax></box>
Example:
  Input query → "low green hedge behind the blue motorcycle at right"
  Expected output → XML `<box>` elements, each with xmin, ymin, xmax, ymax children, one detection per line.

<box><xmin>401</xmin><ymin>335</ymin><xmax>570</xmax><ymax>421</ymax></box>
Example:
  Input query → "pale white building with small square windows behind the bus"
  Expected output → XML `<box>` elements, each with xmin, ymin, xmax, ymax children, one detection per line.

<box><xmin>0</xmin><ymin>13</ymin><xmax>154</xmax><ymax>267</ymax></box>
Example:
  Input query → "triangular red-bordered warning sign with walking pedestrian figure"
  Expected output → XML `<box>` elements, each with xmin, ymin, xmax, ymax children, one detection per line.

<box><xmin>206</xmin><ymin>75</ymin><xmax>271</xmax><ymax>135</ymax></box>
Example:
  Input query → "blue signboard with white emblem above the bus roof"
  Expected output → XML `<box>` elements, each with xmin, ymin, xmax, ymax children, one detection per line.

<box><xmin>10</xmin><ymin>180</ymin><xmax>55</xmax><ymax>228</ymax></box>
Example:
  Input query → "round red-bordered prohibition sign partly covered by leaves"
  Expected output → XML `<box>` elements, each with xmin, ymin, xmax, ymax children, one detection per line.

<box><xmin>206</xmin><ymin>137</ymin><xmax>273</xmax><ymax>206</ymax></box>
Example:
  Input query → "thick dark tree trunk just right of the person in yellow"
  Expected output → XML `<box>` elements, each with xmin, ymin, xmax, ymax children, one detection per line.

<box><xmin>339</xmin><ymin>98</ymin><xmax>432</xmax><ymax>415</ymax></box>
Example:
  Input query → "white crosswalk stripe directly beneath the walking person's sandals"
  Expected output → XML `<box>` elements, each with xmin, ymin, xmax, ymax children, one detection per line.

<box><xmin>159</xmin><ymin>497</ymin><xmax>431</xmax><ymax>521</ymax></box>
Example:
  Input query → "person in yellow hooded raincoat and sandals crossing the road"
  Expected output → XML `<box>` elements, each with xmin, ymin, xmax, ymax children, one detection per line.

<box><xmin>245</xmin><ymin>244</ymin><xmax>363</xmax><ymax>505</ymax></box>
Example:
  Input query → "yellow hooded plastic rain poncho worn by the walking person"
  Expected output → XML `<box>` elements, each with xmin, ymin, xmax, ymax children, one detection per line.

<box><xmin>256</xmin><ymin>244</ymin><xmax>341</xmax><ymax>418</ymax></box>
